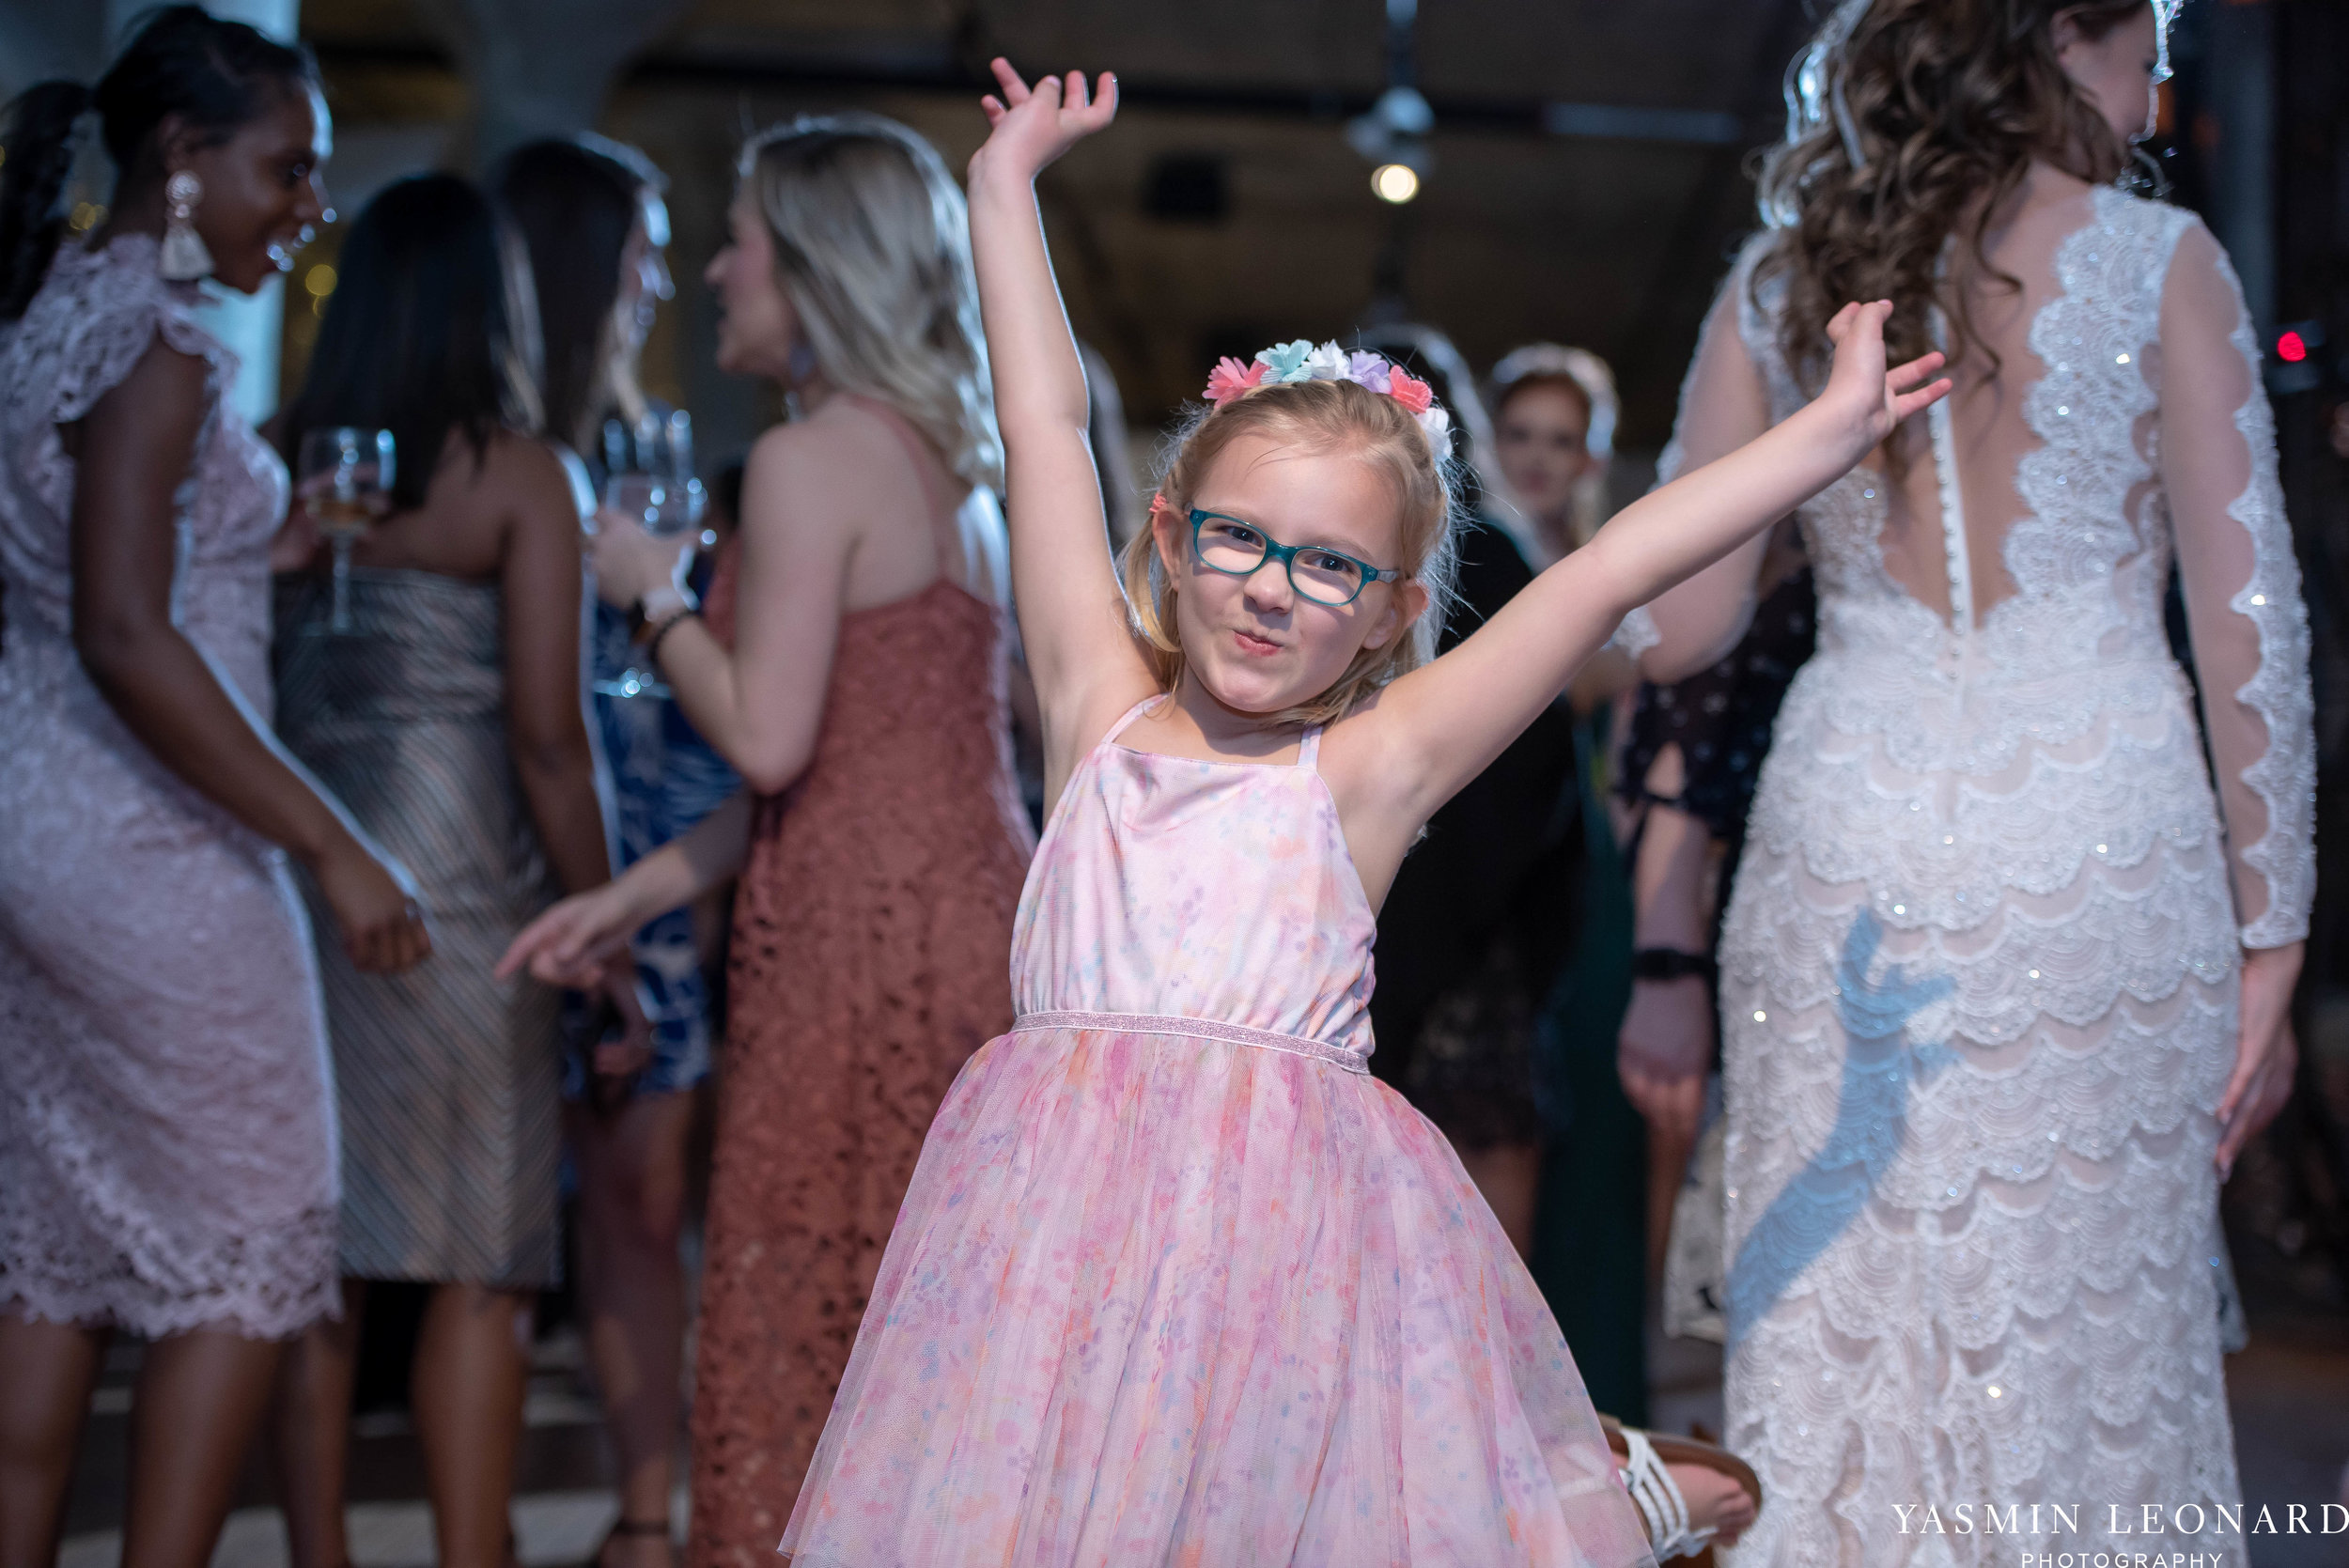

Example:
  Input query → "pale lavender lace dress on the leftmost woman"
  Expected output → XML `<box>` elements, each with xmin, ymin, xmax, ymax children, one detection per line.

<box><xmin>0</xmin><ymin>237</ymin><xmax>336</xmax><ymax>1338</ymax></box>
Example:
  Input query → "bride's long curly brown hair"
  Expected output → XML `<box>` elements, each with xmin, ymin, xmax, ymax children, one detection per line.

<box><xmin>1755</xmin><ymin>0</ymin><xmax>2150</xmax><ymax>387</ymax></box>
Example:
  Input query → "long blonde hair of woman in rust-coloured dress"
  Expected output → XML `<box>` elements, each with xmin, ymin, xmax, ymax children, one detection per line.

<box><xmin>738</xmin><ymin>113</ymin><xmax>1003</xmax><ymax>490</ymax></box>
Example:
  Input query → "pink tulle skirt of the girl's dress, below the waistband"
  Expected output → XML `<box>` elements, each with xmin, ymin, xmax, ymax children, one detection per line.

<box><xmin>783</xmin><ymin>1031</ymin><xmax>1652</xmax><ymax>1568</ymax></box>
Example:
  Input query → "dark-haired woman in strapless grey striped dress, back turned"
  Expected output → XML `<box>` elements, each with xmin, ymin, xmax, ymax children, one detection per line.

<box><xmin>275</xmin><ymin>174</ymin><xmax>628</xmax><ymax>1568</ymax></box>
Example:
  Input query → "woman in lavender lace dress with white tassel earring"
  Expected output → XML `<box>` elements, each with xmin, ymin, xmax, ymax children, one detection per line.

<box><xmin>0</xmin><ymin>5</ymin><xmax>430</xmax><ymax>1568</ymax></box>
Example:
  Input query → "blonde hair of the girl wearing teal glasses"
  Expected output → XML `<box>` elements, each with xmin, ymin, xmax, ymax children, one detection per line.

<box><xmin>1121</xmin><ymin>380</ymin><xmax>1459</xmax><ymax>725</ymax></box>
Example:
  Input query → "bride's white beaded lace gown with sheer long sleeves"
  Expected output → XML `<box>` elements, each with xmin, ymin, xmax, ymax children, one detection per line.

<box><xmin>1682</xmin><ymin>190</ymin><xmax>2314</xmax><ymax>1568</ymax></box>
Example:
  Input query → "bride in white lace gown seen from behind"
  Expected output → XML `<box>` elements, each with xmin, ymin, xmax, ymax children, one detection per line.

<box><xmin>1644</xmin><ymin>0</ymin><xmax>2314</xmax><ymax>1568</ymax></box>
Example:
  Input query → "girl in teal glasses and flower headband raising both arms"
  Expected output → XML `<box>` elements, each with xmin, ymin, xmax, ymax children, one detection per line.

<box><xmin>783</xmin><ymin>61</ymin><xmax>1945</xmax><ymax>1568</ymax></box>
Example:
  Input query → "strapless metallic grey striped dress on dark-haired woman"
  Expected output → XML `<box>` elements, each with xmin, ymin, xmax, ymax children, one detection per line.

<box><xmin>277</xmin><ymin>568</ymin><xmax>562</xmax><ymax>1289</ymax></box>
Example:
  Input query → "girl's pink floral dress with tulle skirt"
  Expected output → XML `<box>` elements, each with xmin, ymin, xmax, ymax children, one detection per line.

<box><xmin>783</xmin><ymin>705</ymin><xmax>1652</xmax><ymax>1568</ymax></box>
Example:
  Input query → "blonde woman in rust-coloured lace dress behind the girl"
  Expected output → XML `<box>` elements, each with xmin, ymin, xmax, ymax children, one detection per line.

<box><xmin>506</xmin><ymin>115</ymin><xmax>1032</xmax><ymax>1566</ymax></box>
